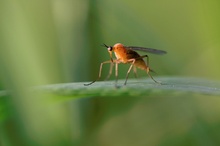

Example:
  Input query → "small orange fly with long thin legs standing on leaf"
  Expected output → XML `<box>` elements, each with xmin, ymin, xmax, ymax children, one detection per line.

<box><xmin>84</xmin><ymin>43</ymin><xmax>166</xmax><ymax>86</ymax></box>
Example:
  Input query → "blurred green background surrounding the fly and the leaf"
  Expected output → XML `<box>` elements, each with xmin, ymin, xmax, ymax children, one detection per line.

<box><xmin>0</xmin><ymin>0</ymin><xmax>220</xmax><ymax>146</ymax></box>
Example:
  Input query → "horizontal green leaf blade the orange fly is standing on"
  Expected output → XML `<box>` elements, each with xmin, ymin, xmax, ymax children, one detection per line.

<box><xmin>32</xmin><ymin>77</ymin><xmax>220</xmax><ymax>97</ymax></box>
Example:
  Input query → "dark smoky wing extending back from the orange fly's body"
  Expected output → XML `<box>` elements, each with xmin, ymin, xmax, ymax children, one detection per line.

<box><xmin>126</xmin><ymin>46</ymin><xmax>167</xmax><ymax>55</ymax></box>
